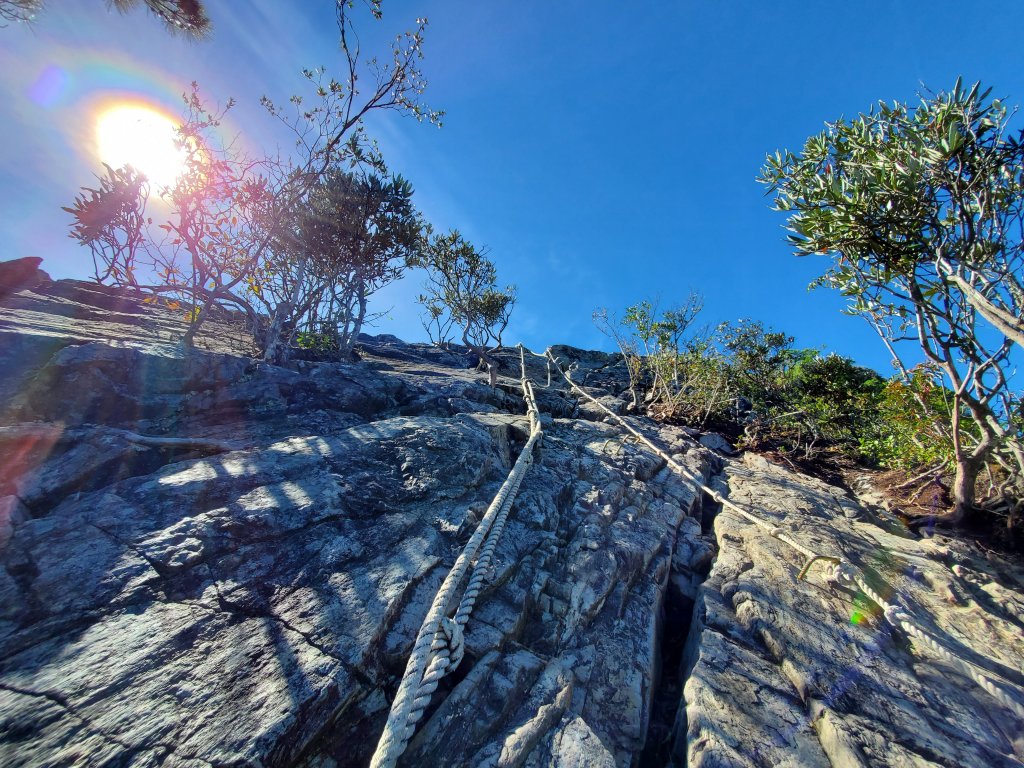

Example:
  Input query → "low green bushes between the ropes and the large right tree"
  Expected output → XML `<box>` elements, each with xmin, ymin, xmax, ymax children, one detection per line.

<box><xmin>594</xmin><ymin>294</ymin><xmax>885</xmax><ymax>461</ymax></box>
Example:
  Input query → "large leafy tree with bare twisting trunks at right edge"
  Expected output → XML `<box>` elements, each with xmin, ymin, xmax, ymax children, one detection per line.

<box><xmin>759</xmin><ymin>80</ymin><xmax>1024</xmax><ymax>522</ymax></box>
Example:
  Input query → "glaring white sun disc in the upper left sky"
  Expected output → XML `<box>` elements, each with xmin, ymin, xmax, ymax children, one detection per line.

<box><xmin>96</xmin><ymin>104</ymin><xmax>185</xmax><ymax>189</ymax></box>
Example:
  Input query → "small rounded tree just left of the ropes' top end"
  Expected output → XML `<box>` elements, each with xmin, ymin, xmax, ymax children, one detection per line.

<box><xmin>417</xmin><ymin>229</ymin><xmax>515</xmax><ymax>383</ymax></box>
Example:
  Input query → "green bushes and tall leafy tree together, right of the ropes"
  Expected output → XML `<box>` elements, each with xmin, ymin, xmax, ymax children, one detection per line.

<box><xmin>595</xmin><ymin>82</ymin><xmax>1024</xmax><ymax>528</ymax></box>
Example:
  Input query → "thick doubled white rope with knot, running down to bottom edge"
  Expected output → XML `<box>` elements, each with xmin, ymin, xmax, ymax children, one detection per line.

<box><xmin>370</xmin><ymin>349</ymin><xmax>544</xmax><ymax>768</ymax></box>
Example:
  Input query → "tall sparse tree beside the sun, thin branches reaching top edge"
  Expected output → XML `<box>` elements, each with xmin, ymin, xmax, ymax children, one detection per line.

<box><xmin>62</xmin><ymin>0</ymin><xmax>442</xmax><ymax>356</ymax></box>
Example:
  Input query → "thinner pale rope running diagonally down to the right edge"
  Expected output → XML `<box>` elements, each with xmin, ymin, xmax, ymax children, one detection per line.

<box><xmin>531</xmin><ymin>349</ymin><xmax>1024</xmax><ymax>718</ymax></box>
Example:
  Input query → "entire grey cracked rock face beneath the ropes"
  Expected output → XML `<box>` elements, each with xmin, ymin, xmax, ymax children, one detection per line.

<box><xmin>0</xmin><ymin>274</ymin><xmax>1024</xmax><ymax>768</ymax></box>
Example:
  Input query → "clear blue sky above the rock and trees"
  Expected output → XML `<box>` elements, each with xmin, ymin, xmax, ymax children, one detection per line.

<box><xmin>0</xmin><ymin>0</ymin><xmax>1024</xmax><ymax>371</ymax></box>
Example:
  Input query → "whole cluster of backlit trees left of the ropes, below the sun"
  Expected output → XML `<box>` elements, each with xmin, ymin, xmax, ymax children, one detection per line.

<box><xmin>65</xmin><ymin>3</ymin><xmax>515</xmax><ymax>370</ymax></box>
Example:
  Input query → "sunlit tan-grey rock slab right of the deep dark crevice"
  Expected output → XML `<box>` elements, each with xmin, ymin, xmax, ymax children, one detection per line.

<box><xmin>676</xmin><ymin>455</ymin><xmax>1024</xmax><ymax>766</ymax></box>
